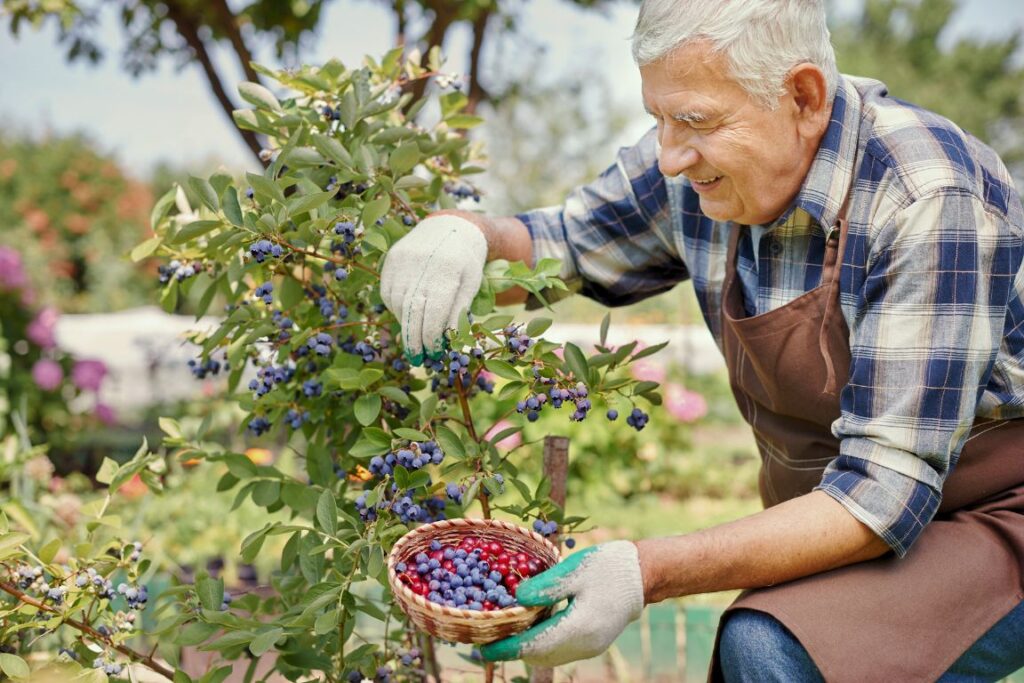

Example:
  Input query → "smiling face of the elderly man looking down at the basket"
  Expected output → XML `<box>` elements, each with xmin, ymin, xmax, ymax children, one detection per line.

<box><xmin>640</xmin><ymin>42</ymin><xmax>817</xmax><ymax>225</ymax></box>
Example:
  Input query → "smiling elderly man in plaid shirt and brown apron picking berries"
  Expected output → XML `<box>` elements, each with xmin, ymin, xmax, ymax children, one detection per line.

<box><xmin>383</xmin><ymin>0</ymin><xmax>1024</xmax><ymax>681</ymax></box>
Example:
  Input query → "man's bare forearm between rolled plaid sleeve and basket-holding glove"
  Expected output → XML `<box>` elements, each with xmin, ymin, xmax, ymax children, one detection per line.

<box><xmin>636</xmin><ymin>490</ymin><xmax>890</xmax><ymax>604</ymax></box>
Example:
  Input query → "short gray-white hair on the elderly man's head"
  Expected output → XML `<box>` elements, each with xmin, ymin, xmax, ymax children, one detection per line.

<box><xmin>633</xmin><ymin>0</ymin><xmax>839</xmax><ymax>110</ymax></box>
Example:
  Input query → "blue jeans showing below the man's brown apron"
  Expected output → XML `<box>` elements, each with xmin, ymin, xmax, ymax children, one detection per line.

<box><xmin>719</xmin><ymin>602</ymin><xmax>1024</xmax><ymax>683</ymax></box>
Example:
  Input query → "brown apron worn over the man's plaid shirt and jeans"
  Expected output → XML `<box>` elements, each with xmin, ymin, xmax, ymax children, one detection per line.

<box><xmin>711</xmin><ymin>200</ymin><xmax>1024</xmax><ymax>683</ymax></box>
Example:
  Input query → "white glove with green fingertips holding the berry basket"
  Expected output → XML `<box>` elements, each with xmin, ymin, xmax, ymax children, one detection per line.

<box><xmin>480</xmin><ymin>541</ymin><xmax>643</xmax><ymax>667</ymax></box>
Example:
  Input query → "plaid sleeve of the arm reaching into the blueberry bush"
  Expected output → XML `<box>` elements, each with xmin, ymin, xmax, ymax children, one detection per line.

<box><xmin>516</xmin><ymin>129</ymin><xmax>688</xmax><ymax>307</ymax></box>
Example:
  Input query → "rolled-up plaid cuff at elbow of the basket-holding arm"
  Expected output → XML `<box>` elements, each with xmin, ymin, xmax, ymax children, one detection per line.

<box><xmin>815</xmin><ymin>446</ymin><xmax>942</xmax><ymax>557</ymax></box>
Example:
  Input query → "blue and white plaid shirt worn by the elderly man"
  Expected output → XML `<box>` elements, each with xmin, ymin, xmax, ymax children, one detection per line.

<box><xmin>519</xmin><ymin>76</ymin><xmax>1024</xmax><ymax>556</ymax></box>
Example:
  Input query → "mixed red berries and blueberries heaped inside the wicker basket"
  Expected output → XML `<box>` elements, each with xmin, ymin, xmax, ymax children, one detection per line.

<box><xmin>395</xmin><ymin>536</ymin><xmax>545</xmax><ymax>611</ymax></box>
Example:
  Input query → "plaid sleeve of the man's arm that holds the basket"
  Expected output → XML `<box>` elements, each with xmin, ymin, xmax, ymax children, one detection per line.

<box><xmin>817</xmin><ymin>190</ymin><xmax>1021</xmax><ymax>557</ymax></box>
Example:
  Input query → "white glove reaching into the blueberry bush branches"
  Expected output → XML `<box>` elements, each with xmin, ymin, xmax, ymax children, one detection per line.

<box><xmin>381</xmin><ymin>215</ymin><xmax>487</xmax><ymax>366</ymax></box>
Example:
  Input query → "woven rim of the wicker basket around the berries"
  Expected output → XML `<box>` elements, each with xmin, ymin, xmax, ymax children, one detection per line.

<box><xmin>387</xmin><ymin>517</ymin><xmax>561</xmax><ymax>623</ymax></box>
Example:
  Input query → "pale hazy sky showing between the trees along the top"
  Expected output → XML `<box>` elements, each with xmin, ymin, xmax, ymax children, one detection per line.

<box><xmin>0</xmin><ymin>0</ymin><xmax>1024</xmax><ymax>176</ymax></box>
